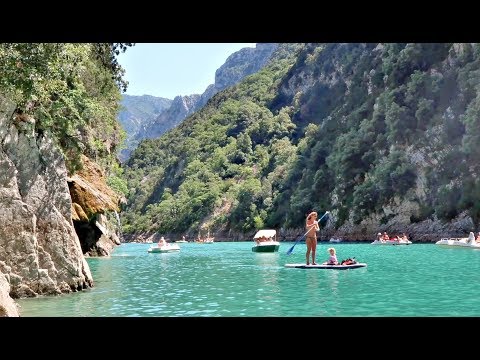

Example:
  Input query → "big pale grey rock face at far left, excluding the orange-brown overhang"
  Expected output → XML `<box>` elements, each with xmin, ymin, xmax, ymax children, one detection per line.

<box><xmin>0</xmin><ymin>97</ymin><xmax>93</xmax><ymax>308</ymax></box>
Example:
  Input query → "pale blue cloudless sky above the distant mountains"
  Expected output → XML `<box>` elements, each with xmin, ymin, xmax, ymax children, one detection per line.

<box><xmin>118</xmin><ymin>43</ymin><xmax>255</xmax><ymax>99</ymax></box>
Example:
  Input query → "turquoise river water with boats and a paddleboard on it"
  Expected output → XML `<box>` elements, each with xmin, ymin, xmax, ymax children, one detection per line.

<box><xmin>18</xmin><ymin>242</ymin><xmax>480</xmax><ymax>317</ymax></box>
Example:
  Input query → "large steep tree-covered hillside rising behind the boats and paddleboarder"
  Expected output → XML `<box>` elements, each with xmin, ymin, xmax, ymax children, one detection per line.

<box><xmin>123</xmin><ymin>44</ymin><xmax>480</xmax><ymax>239</ymax></box>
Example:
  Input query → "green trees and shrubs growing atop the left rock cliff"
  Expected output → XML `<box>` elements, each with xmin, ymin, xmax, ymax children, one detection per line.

<box><xmin>0</xmin><ymin>43</ymin><xmax>131</xmax><ymax>179</ymax></box>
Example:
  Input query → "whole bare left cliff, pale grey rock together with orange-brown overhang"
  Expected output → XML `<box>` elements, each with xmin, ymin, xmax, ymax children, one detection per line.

<box><xmin>0</xmin><ymin>96</ymin><xmax>124</xmax><ymax>316</ymax></box>
